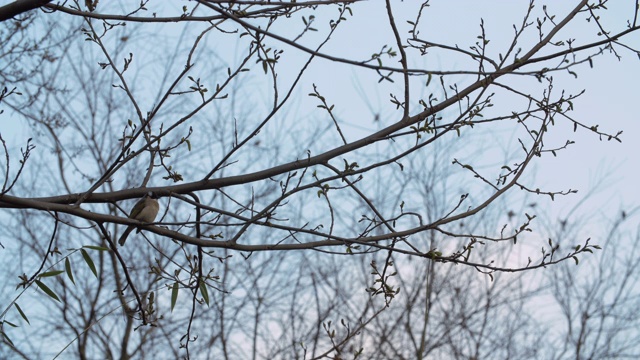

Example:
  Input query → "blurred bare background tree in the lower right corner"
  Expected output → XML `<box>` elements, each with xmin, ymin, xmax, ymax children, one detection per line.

<box><xmin>541</xmin><ymin>208</ymin><xmax>640</xmax><ymax>359</ymax></box>
